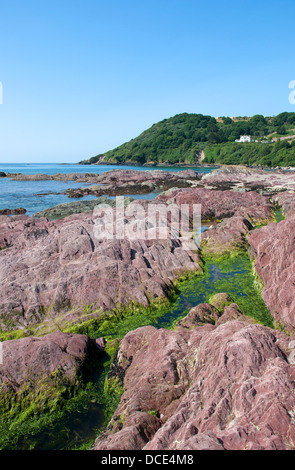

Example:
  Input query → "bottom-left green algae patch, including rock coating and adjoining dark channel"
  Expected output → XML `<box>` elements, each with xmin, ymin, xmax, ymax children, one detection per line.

<box><xmin>0</xmin><ymin>332</ymin><xmax>123</xmax><ymax>450</ymax></box>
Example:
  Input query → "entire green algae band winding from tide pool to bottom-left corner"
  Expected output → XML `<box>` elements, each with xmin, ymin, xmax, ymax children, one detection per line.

<box><xmin>0</xmin><ymin>246</ymin><xmax>273</xmax><ymax>450</ymax></box>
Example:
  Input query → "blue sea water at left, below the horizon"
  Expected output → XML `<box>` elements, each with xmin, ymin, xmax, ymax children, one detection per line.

<box><xmin>0</xmin><ymin>163</ymin><xmax>217</xmax><ymax>215</ymax></box>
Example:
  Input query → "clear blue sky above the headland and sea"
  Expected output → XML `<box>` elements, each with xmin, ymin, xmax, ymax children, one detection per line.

<box><xmin>0</xmin><ymin>0</ymin><xmax>295</xmax><ymax>163</ymax></box>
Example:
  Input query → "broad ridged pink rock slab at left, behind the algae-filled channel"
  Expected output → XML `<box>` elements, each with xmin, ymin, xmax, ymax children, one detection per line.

<box><xmin>0</xmin><ymin>213</ymin><xmax>201</xmax><ymax>329</ymax></box>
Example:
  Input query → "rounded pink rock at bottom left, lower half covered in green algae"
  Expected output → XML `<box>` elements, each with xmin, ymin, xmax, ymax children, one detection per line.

<box><xmin>0</xmin><ymin>332</ymin><xmax>102</xmax><ymax>449</ymax></box>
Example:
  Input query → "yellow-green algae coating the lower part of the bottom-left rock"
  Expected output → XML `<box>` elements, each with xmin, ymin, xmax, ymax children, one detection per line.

<box><xmin>0</xmin><ymin>370</ymin><xmax>100</xmax><ymax>450</ymax></box>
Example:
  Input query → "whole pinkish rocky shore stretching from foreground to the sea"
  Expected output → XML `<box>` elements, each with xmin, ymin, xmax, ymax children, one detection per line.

<box><xmin>0</xmin><ymin>167</ymin><xmax>295</xmax><ymax>451</ymax></box>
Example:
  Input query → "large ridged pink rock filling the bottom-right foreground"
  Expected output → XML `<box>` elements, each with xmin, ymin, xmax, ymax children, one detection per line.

<box><xmin>93</xmin><ymin>312</ymin><xmax>295</xmax><ymax>451</ymax></box>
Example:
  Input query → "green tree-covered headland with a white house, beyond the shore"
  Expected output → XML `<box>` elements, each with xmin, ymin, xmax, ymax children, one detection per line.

<box><xmin>80</xmin><ymin>112</ymin><xmax>295</xmax><ymax>167</ymax></box>
